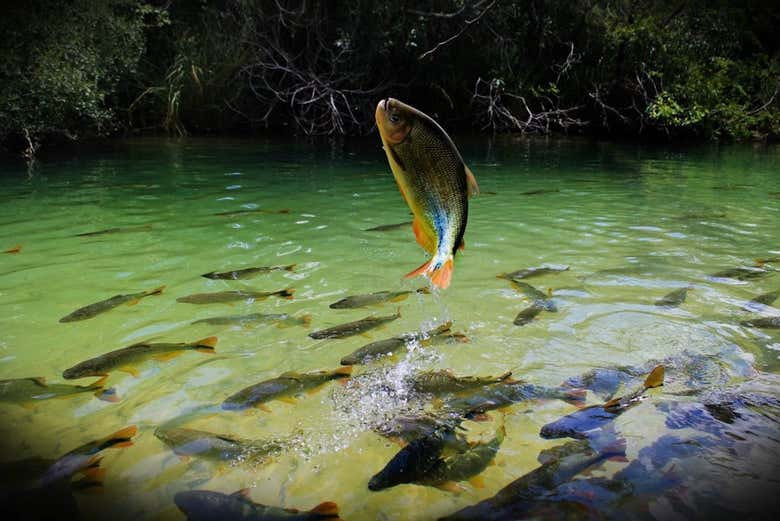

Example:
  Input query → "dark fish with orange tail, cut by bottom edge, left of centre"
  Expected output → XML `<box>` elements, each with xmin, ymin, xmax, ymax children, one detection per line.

<box><xmin>173</xmin><ymin>489</ymin><xmax>339</xmax><ymax>521</ymax></box>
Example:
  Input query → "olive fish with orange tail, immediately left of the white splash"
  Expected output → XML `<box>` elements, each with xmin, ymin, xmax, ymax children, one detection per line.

<box><xmin>222</xmin><ymin>367</ymin><xmax>352</xmax><ymax>412</ymax></box>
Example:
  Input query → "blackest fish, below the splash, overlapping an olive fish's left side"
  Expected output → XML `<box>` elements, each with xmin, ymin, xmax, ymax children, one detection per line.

<box><xmin>368</xmin><ymin>431</ymin><xmax>445</xmax><ymax>492</ymax></box>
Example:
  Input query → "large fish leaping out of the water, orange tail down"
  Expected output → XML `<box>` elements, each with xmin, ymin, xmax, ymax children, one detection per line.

<box><xmin>375</xmin><ymin>98</ymin><xmax>479</xmax><ymax>289</ymax></box>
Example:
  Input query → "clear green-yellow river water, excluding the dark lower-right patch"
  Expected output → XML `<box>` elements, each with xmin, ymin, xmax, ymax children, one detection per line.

<box><xmin>0</xmin><ymin>138</ymin><xmax>780</xmax><ymax>520</ymax></box>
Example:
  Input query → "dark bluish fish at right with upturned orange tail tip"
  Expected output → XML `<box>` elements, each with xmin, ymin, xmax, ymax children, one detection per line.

<box><xmin>540</xmin><ymin>365</ymin><xmax>664</xmax><ymax>439</ymax></box>
